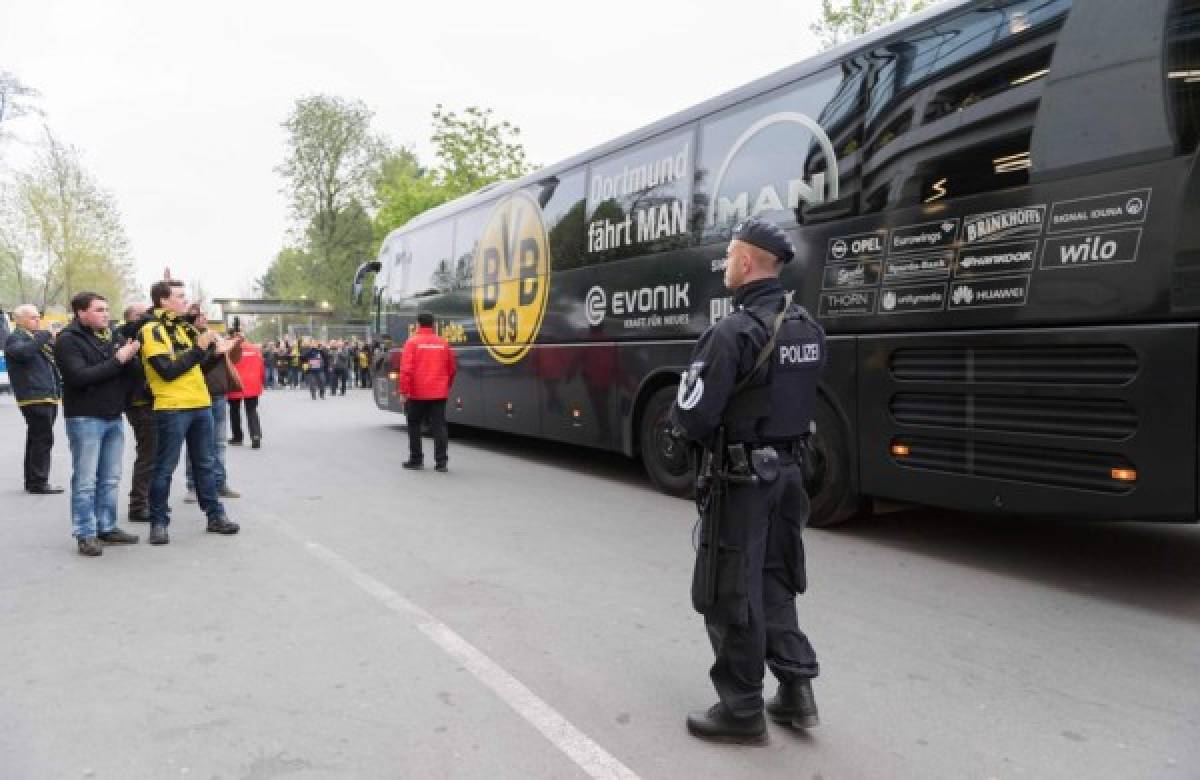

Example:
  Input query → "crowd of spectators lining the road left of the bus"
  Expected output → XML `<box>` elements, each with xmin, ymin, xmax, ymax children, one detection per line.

<box><xmin>4</xmin><ymin>280</ymin><xmax>378</xmax><ymax>557</ymax></box>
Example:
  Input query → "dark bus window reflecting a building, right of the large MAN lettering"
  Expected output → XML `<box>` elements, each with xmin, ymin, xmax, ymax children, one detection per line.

<box><xmin>863</xmin><ymin>0</ymin><xmax>1070</xmax><ymax>211</ymax></box>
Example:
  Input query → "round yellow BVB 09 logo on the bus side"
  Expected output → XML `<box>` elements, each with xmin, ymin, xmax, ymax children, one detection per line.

<box><xmin>474</xmin><ymin>192</ymin><xmax>550</xmax><ymax>364</ymax></box>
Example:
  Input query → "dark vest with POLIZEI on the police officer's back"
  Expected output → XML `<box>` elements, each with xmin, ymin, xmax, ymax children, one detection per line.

<box><xmin>724</xmin><ymin>306</ymin><xmax>826</xmax><ymax>442</ymax></box>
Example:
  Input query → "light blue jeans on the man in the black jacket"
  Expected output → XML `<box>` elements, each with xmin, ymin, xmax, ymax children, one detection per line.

<box><xmin>66</xmin><ymin>418</ymin><xmax>125</xmax><ymax>539</ymax></box>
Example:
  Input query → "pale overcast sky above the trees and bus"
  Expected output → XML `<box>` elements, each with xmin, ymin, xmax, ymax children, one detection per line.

<box><xmin>0</xmin><ymin>0</ymin><xmax>821</xmax><ymax>296</ymax></box>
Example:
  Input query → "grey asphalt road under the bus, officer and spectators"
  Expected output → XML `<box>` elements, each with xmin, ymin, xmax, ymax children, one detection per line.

<box><xmin>0</xmin><ymin>391</ymin><xmax>1200</xmax><ymax>780</ymax></box>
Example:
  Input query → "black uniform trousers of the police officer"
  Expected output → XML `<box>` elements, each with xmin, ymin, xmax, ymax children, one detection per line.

<box><xmin>704</xmin><ymin>457</ymin><xmax>818</xmax><ymax>716</ymax></box>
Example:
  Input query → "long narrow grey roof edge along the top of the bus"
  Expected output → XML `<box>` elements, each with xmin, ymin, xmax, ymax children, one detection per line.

<box><xmin>398</xmin><ymin>0</ymin><xmax>982</xmax><ymax>235</ymax></box>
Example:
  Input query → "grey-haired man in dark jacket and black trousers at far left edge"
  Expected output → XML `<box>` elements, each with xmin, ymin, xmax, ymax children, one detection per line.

<box><xmin>4</xmin><ymin>304</ymin><xmax>62</xmax><ymax>494</ymax></box>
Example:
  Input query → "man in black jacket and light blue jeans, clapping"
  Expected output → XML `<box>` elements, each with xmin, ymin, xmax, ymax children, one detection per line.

<box><xmin>54</xmin><ymin>293</ymin><xmax>139</xmax><ymax>557</ymax></box>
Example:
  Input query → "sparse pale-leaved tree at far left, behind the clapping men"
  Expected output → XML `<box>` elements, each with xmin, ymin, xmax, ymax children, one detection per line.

<box><xmin>0</xmin><ymin>131</ymin><xmax>133</xmax><ymax>307</ymax></box>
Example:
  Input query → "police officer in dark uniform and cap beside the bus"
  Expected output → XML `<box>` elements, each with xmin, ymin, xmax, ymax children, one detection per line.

<box><xmin>672</xmin><ymin>218</ymin><xmax>824</xmax><ymax>744</ymax></box>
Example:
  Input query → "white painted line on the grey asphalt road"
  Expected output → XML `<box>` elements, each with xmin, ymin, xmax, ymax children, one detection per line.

<box><xmin>288</xmin><ymin>524</ymin><xmax>637</xmax><ymax>780</ymax></box>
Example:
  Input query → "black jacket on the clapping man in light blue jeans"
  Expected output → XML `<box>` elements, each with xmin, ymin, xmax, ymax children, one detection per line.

<box><xmin>54</xmin><ymin>319</ymin><xmax>132</xmax><ymax>420</ymax></box>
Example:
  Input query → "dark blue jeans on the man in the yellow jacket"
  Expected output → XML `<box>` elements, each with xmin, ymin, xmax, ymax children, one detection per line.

<box><xmin>150</xmin><ymin>407</ymin><xmax>224</xmax><ymax>526</ymax></box>
